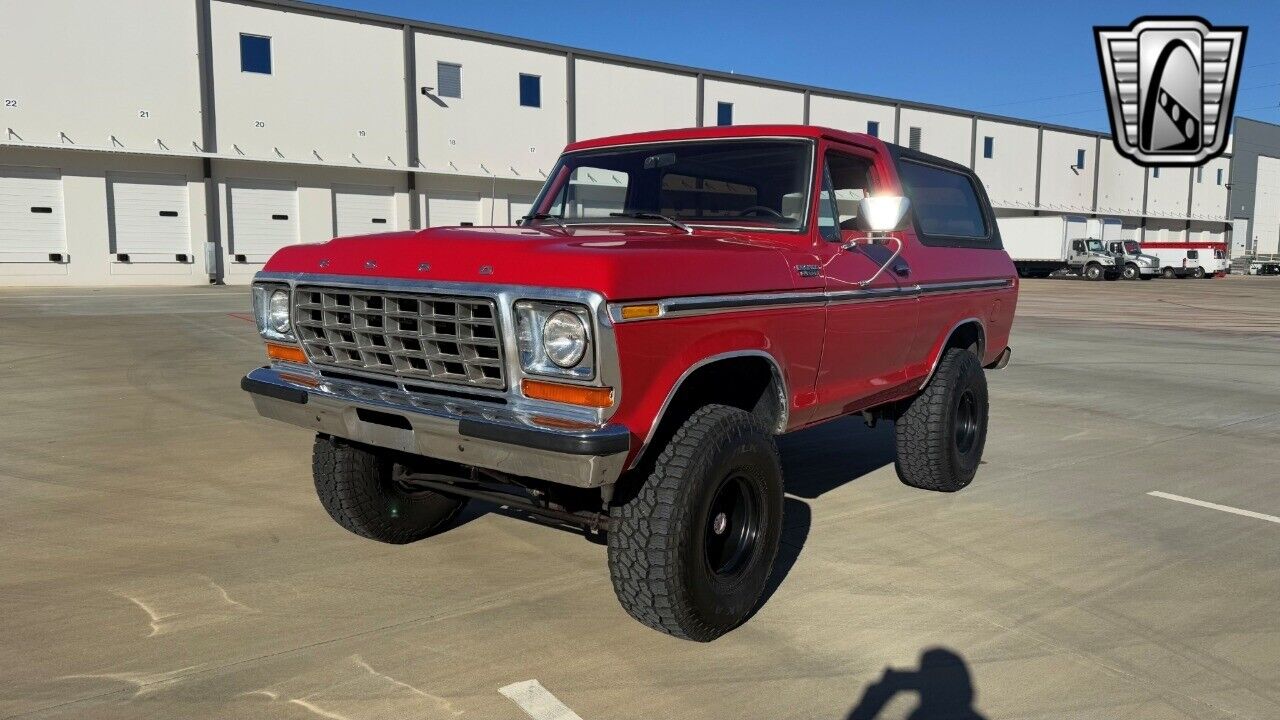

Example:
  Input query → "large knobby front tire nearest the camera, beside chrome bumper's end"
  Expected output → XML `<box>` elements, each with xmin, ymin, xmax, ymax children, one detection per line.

<box><xmin>608</xmin><ymin>405</ymin><xmax>783</xmax><ymax>642</ymax></box>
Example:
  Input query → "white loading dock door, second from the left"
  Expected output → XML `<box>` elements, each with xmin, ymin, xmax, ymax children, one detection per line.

<box><xmin>106</xmin><ymin>173</ymin><xmax>192</xmax><ymax>263</ymax></box>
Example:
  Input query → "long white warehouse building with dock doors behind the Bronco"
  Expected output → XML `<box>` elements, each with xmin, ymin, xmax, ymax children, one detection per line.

<box><xmin>0</xmin><ymin>0</ymin><xmax>1280</xmax><ymax>286</ymax></box>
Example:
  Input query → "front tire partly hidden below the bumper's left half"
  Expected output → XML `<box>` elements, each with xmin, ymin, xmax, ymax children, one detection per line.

<box><xmin>311</xmin><ymin>436</ymin><xmax>466</xmax><ymax>544</ymax></box>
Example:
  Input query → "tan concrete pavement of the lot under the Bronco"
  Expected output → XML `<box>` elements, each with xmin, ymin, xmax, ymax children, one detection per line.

<box><xmin>0</xmin><ymin>278</ymin><xmax>1280</xmax><ymax>720</ymax></box>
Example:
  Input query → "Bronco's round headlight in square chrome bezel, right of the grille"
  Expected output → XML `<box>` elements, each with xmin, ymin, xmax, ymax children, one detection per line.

<box><xmin>516</xmin><ymin>300</ymin><xmax>595</xmax><ymax>379</ymax></box>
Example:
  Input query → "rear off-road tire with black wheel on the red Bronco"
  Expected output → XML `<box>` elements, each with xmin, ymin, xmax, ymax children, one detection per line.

<box><xmin>893</xmin><ymin>347</ymin><xmax>988</xmax><ymax>492</ymax></box>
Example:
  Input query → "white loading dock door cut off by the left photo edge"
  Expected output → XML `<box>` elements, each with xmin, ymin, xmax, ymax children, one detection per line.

<box><xmin>0</xmin><ymin>165</ymin><xmax>67</xmax><ymax>263</ymax></box>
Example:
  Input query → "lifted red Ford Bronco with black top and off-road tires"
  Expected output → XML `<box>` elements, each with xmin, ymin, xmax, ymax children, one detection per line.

<box><xmin>242</xmin><ymin>126</ymin><xmax>1018</xmax><ymax>641</ymax></box>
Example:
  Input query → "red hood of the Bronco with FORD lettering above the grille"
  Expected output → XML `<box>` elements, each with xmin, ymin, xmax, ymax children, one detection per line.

<box><xmin>262</xmin><ymin>225</ymin><xmax>795</xmax><ymax>300</ymax></box>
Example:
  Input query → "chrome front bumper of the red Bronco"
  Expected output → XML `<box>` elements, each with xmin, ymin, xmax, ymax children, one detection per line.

<box><xmin>241</xmin><ymin>368</ymin><xmax>631</xmax><ymax>487</ymax></box>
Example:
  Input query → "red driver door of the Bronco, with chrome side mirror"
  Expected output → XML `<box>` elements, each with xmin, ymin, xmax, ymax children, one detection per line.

<box><xmin>814</xmin><ymin>145</ymin><xmax>919</xmax><ymax>418</ymax></box>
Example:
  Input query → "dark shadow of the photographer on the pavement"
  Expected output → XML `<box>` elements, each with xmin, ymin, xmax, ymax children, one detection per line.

<box><xmin>845</xmin><ymin>647</ymin><xmax>986</xmax><ymax>720</ymax></box>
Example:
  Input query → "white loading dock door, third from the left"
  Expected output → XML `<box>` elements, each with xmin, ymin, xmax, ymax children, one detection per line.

<box><xmin>227</xmin><ymin>179</ymin><xmax>298</xmax><ymax>263</ymax></box>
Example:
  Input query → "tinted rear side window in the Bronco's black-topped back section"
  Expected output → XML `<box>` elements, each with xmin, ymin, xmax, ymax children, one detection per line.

<box><xmin>899</xmin><ymin>159</ymin><xmax>991</xmax><ymax>245</ymax></box>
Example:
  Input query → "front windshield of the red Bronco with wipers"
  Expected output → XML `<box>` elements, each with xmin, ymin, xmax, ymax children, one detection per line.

<box><xmin>532</xmin><ymin>140</ymin><xmax>813</xmax><ymax>229</ymax></box>
